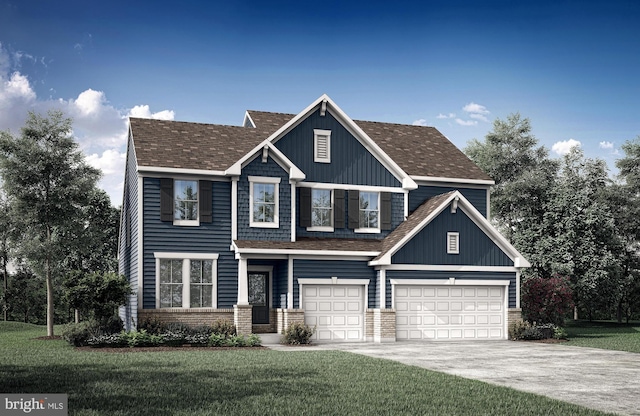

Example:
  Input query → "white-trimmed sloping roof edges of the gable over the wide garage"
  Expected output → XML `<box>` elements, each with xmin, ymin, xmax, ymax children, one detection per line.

<box><xmin>370</xmin><ymin>191</ymin><xmax>530</xmax><ymax>267</ymax></box>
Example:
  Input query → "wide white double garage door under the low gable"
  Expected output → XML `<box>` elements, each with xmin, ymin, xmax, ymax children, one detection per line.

<box><xmin>395</xmin><ymin>285</ymin><xmax>506</xmax><ymax>340</ymax></box>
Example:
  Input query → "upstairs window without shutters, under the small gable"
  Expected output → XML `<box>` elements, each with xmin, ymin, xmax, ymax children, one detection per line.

<box><xmin>249</xmin><ymin>176</ymin><xmax>280</xmax><ymax>228</ymax></box>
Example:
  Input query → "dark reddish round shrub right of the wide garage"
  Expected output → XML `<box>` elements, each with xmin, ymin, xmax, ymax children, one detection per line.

<box><xmin>522</xmin><ymin>276</ymin><xmax>573</xmax><ymax>326</ymax></box>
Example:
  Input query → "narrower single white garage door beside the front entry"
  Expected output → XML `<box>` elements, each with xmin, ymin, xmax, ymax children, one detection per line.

<box><xmin>302</xmin><ymin>285</ymin><xmax>364</xmax><ymax>341</ymax></box>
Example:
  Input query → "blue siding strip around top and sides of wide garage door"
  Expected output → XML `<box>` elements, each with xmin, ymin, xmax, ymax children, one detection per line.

<box><xmin>386</xmin><ymin>270</ymin><xmax>516</xmax><ymax>308</ymax></box>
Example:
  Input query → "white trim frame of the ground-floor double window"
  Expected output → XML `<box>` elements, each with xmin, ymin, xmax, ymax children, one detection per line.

<box><xmin>153</xmin><ymin>252</ymin><xmax>219</xmax><ymax>309</ymax></box>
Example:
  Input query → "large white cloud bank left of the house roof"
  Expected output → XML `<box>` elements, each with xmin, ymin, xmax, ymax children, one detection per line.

<box><xmin>0</xmin><ymin>43</ymin><xmax>174</xmax><ymax>205</ymax></box>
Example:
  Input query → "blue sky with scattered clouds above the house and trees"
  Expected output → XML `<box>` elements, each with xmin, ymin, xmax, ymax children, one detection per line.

<box><xmin>0</xmin><ymin>0</ymin><xmax>640</xmax><ymax>205</ymax></box>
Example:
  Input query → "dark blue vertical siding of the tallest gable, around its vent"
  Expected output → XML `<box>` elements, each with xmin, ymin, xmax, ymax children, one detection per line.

<box><xmin>275</xmin><ymin>111</ymin><xmax>401</xmax><ymax>187</ymax></box>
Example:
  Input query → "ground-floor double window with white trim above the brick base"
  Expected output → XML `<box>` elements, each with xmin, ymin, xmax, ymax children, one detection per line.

<box><xmin>154</xmin><ymin>253</ymin><xmax>218</xmax><ymax>308</ymax></box>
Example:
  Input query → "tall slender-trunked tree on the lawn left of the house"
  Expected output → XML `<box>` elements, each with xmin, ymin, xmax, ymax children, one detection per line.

<box><xmin>0</xmin><ymin>111</ymin><xmax>100</xmax><ymax>336</ymax></box>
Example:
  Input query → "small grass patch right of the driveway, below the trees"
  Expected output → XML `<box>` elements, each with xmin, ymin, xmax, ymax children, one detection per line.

<box><xmin>565</xmin><ymin>321</ymin><xmax>640</xmax><ymax>353</ymax></box>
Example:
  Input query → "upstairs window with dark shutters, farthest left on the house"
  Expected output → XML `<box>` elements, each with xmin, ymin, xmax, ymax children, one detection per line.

<box><xmin>160</xmin><ymin>178</ymin><xmax>213</xmax><ymax>226</ymax></box>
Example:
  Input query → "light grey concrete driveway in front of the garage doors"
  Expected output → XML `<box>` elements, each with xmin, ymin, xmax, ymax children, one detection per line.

<box><xmin>272</xmin><ymin>341</ymin><xmax>640</xmax><ymax>415</ymax></box>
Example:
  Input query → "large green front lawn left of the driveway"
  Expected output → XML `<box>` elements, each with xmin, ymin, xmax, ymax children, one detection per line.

<box><xmin>0</xmin><ymin>322</ymin><xmax>603</xmax><ymax>416</ymax></box>
